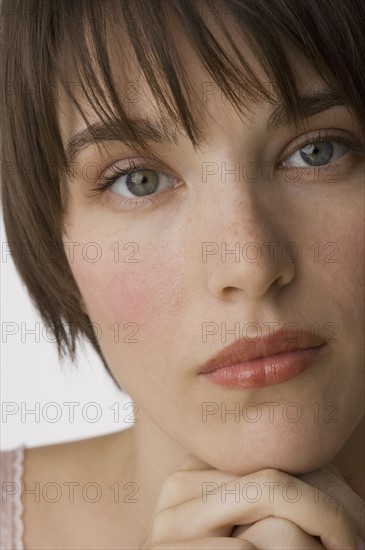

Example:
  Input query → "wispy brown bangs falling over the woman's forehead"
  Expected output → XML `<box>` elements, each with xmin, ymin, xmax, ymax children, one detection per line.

<box><xmin>40</xmin><ymin>0</ymin><xmax>364</xmax><ymax>172</ymax></box>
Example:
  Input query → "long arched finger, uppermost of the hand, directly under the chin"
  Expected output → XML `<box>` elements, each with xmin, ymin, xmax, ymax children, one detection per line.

<box><xmin>155</xmin><ymin>469</ymin><xmax>356</xmax><ymax>550</ymax></box>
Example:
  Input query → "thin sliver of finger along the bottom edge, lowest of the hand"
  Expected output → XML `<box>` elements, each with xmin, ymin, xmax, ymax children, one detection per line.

<box><xmin>149</xmin><ymin>537</ymin><xmax>257</xmax><ymax>550</ymax></box>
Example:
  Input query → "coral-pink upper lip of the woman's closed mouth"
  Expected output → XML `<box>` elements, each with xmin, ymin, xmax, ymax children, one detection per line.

<box><xmin>199</xmin><ymin>329</ymin><xmax>325</xmax><ymax>374</ymax></box>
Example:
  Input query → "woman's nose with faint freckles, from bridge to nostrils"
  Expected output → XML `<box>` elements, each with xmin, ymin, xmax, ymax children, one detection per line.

<box><xmin>200</xmin><ymin>183</ymin><xmax>296</xmax><ymax>300</ymax></box>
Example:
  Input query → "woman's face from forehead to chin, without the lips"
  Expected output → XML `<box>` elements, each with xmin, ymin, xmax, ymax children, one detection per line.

<box><xmin>60</xmin><ymin>23</ymin><xmax>364</xmax><ymax>475</ymax></box>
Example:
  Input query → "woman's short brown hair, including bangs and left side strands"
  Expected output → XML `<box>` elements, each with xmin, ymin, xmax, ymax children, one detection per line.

<box><xmin>0</xmin><ymin>0</ymin><xmax>365</xmax><ymax>388</ymax></box>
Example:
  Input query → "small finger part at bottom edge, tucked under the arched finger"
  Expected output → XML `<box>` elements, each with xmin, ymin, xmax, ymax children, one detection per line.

<box><xmin>231</xmin><ymin>517</ymin><xmax>324</xmax><ymax>550</ymax></box>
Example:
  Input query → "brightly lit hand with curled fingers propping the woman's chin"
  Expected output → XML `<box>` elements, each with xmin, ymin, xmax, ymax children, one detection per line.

<box><xmin>141</xmin><ymin>455</ymin><xmax>356</xmax><ymax>550</ymax></box>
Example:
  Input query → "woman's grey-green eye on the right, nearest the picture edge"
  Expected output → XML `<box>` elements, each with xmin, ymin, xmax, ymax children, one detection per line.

<box><xmin>282</xmin><ymin>133</ymin><xmax>363</xmax><ymax>168</ymax></box>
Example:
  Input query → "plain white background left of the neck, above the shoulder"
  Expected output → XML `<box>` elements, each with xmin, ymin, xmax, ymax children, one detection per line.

<box><xmin>0</xmin><ymin>218</ymin><xmax>133</xmax><ymax>450</ymax></box>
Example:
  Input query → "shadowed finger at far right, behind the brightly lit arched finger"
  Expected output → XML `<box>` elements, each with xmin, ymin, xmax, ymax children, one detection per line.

<box><xmin>297</xmin><ymin>467</ymin><xmax>365</xmax><ymax>538</ymax></box>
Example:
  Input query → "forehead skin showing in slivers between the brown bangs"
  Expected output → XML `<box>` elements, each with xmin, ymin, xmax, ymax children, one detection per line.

<box><xmin>57</xmin><ymin>5</ymin><xmax>324</xmax><ymax>153</ymax></box>
